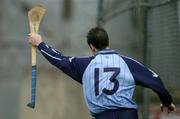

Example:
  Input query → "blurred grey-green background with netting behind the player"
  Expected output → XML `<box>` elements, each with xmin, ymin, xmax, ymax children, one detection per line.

<box><xmin>0</xmin><ymin>0</ymin><xmax>180</xmax><ymax>119</ymax></box>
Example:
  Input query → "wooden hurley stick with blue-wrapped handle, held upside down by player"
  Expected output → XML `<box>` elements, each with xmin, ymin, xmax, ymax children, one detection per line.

<box><xmin>27</xmin><ymin>6</ymin><xmax>46</xmax><ymax>108</ymax></box>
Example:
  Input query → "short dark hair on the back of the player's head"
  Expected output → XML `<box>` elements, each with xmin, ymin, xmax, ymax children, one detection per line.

<box><xmin>87</xmin><ymin>27</ymin><xmax>109</xmax><ymax>50</ymax></box>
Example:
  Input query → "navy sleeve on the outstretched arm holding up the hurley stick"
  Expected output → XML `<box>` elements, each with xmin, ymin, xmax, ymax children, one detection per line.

<box><xmin>38</xmin><ymin>42</ymin><xmax>92</xmax><ymax>83</ymax></box>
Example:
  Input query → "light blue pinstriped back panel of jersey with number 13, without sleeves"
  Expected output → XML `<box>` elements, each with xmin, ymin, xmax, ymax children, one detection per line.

<box><xmin>83</xmin><ymin>51</ymin><xmax>137</xmax><ymax>114</ymax></box>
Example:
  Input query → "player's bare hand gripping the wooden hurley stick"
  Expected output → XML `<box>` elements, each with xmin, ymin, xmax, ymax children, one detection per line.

<box><xmin>28</xmin><ymin>33</ymin><xmax>43</xmax><ymax>46</ymax></box>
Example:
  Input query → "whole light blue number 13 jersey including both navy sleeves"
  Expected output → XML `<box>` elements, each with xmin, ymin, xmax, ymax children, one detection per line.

<box><xmin>38</xmin><ymin>42</ymin><xmax>172</xmax><ymax>115</ymax></box>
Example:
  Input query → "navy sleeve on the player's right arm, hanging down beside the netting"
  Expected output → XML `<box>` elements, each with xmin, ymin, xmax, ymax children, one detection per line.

<box><xmin>122</xmin><ymin>56</ymin><xmax>172</xmax><ymax>106</ymax></box>
